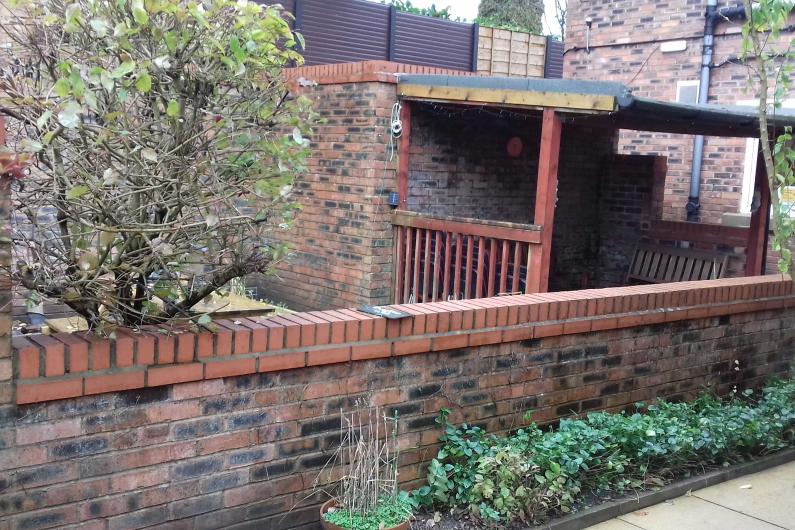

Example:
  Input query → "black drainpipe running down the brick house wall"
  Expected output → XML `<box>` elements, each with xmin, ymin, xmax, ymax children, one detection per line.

<box><xmin>686</xmin><ymin>0</ymin><xmax>745</xmax><ymax>221</ymax></box>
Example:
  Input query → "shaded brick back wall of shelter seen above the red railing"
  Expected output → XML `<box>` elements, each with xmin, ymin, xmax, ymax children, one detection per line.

<box><xmin>408</xmin><ymin>103</ymin><xmax>541</xmax><ymax>224</ymax></box>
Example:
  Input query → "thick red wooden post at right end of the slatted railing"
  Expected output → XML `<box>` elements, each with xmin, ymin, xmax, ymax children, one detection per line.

<box><xmin>527</xmin><ymin>109</ymin><xmax>562</xmax><ymax>293</ymax></box>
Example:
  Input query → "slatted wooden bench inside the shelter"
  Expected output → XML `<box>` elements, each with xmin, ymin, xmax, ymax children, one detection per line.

<box><xmin>627</xmin><ymin>245</ymin><xmax>729</xmax><ymax>283</ymax></box>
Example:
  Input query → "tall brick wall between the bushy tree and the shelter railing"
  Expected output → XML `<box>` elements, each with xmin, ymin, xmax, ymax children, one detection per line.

<box><xmin>259</xmin><ymin>78</ymin><xmax>397</xmax><ymax>309</ymax></box>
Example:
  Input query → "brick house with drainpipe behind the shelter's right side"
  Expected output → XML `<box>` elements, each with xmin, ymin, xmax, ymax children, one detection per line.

<box><xmin>564</xmin><ymin>0</ymin><xmax>789</xmax><ymax>270</ymax></box>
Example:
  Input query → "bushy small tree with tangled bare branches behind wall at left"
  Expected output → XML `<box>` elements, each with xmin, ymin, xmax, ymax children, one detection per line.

<box><xmin>0</xmin><ymin>0</ymin><xmax>311</xmax><ymax>327</ymax></box>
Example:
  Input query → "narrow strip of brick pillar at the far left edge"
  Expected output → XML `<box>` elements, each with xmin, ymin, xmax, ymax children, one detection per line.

<box><xmin>0</xmin><ymin>116</ymin><xmax>14</xmax><ymax>404</ymax></box>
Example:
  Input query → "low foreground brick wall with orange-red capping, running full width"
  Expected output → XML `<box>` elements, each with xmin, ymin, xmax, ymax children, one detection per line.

<box><xmin>0</xmin><ymin>276</ymin><xmax>795</xmax><ymax>530</ymax></box>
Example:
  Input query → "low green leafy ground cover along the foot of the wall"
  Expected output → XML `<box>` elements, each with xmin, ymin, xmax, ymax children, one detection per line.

<box><xmin>412</xmin><ymin>380</ymin><xmax>795</xmax><ymax>524</ymax></box>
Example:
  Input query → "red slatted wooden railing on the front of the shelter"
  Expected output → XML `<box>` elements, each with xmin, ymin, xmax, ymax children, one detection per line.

<box><xmin>392</xmin><ymin>210</ymin><xmax>541</xmax><ymax>303</ymax></box>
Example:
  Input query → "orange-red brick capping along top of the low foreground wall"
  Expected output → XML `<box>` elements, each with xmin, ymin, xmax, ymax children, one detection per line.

<box><xmin>13</xmin><ymin>275</ymin><xmax>795</xmax><ymax>404</ymax></box>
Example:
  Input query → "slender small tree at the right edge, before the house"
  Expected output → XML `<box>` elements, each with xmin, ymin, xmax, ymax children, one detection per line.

<box><xmin>743</xmin><ymin>0</ymin><xmax>795</xmax><ymax>273</ymax></box>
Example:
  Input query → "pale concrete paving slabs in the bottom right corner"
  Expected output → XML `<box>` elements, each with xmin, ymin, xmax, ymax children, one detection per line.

<box><xmin>589</xmin><ymin>462</ymin><xmax>795</xmax><ymax>530</ymax></box>
